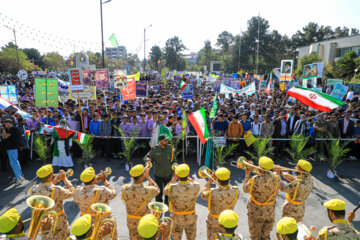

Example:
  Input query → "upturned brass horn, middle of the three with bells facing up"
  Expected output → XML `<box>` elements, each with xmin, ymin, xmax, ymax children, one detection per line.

<box><xmin>90</xmin><ymin>202</ymin><xmax>116</xmax><ymax>240</ymax></box>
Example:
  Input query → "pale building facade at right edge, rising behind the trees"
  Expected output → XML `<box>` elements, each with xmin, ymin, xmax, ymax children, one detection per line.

<box><xmin>297</xmin><ymin>35</ymin><xmax>360</xmax><ymax>65</ymax></box>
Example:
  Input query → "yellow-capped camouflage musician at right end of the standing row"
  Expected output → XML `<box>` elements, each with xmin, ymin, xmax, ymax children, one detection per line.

<box><xmin>275</xmin><ymin>159</ymin><xmax>314</xmax><ymax>222</ymax></box>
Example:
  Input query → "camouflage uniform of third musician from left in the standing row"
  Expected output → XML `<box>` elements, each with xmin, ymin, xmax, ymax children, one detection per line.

<box><xmin>121</xmin><ymin>183</ymin><xmax>160</xmax><ymax>240</ymax></box>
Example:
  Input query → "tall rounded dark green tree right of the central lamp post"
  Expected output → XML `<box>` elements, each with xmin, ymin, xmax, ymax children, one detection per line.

<box><xmin>164</xmin><ymin>36</ymin><xmax>186</xmax><ymax>71</ymax></box>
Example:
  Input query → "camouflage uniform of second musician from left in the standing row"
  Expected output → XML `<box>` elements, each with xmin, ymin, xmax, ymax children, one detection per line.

<box><xmin>74</xmin><ymin>185</ymin><xmax>118</xmax><ymax>240</ymax></box>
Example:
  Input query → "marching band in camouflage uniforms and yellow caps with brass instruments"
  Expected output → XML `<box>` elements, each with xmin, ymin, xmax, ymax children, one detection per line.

<box><xmin>0</xmin><ymin>138</ymin><xmax>360</xmax><ymax>240</ymax></box>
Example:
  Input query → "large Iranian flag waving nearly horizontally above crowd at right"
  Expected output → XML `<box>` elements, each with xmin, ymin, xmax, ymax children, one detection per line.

<box><xmin>286</xmin><ymin>86</ymin><xmax>345</xmax><ymax>112</ymax></box>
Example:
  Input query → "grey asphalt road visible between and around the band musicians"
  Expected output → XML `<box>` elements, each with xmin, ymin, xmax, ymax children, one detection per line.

<box><xmin>0</xmin><ymin>155</ymin><xmax>360</xmax><ymax>240</ymax></box>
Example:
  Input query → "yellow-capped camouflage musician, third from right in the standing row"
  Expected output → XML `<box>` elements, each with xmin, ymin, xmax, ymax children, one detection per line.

<box><xmin>201</xmin><ymin>167</ymin><xmax>240</xmax><ymax>240</ymax></box>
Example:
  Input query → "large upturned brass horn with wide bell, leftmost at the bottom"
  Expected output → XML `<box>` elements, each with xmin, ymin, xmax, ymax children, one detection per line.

<box><xmin>26</xmin><ymin>195</ymin><xmax>58</xmax><ymax>239</ymax></box>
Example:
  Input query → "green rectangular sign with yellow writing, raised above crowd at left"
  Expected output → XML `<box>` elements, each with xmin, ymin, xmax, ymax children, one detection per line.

<box><xmin>35</xmin><ymin>78</ymin><xmax>58</xmax><ymax>107</ymax></box>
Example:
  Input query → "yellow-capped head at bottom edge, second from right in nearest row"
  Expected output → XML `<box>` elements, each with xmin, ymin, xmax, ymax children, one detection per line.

<box><xmin>276</xmin><ymin>217</ymin><xmax>298</xmax><ymax>240</ymax></box>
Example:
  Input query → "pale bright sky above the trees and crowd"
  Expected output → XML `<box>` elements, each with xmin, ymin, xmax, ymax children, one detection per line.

<box><xmin>0</xmin><ymin>0</ymin><xmax>360</xmax><ymax>59</ymax></box>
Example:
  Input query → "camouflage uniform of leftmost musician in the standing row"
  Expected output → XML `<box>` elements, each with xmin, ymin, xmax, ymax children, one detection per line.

<box><xmin>30</xmin><ymin>182</ymin><xmax>75</xmax><ymax>240</ymax></box>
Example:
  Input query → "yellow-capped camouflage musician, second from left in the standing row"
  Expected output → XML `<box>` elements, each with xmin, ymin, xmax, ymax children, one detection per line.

<box><xmin>74</xmin><ymin>167</ymin><xmax>117</xmax><ymax>240</ymax></box>
